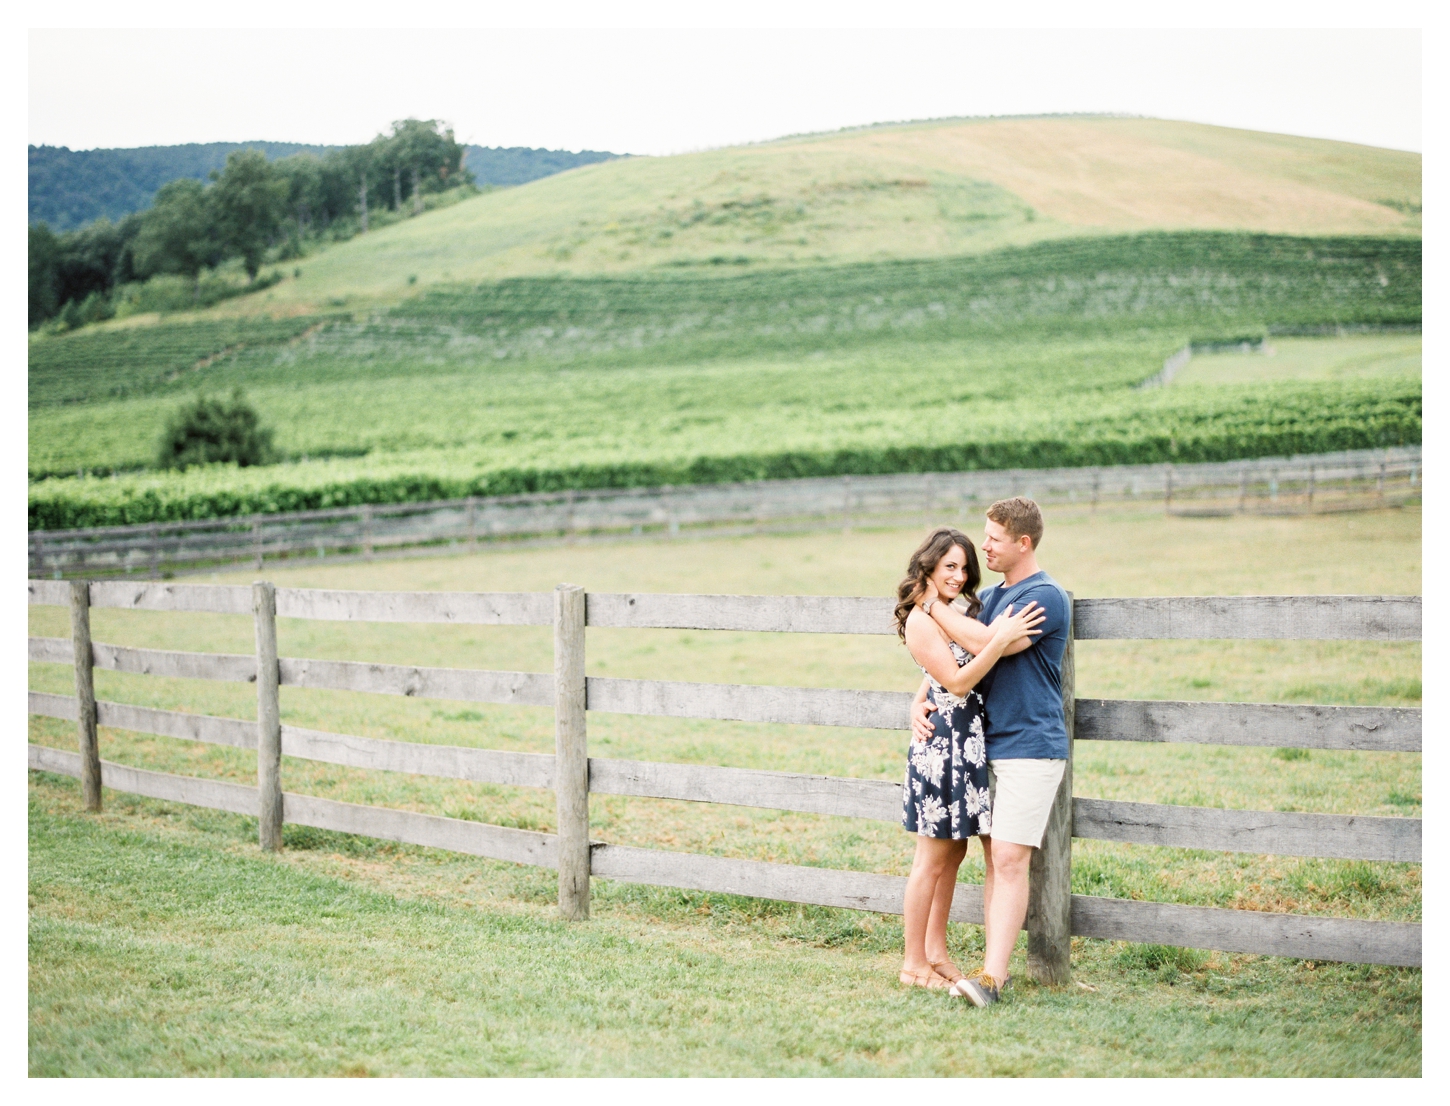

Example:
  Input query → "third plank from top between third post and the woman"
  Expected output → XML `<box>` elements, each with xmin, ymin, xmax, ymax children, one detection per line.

<box><xmin>589</xmin><ymin>757</ymin><xmax>902</xmax><ymax>822</ymax></box>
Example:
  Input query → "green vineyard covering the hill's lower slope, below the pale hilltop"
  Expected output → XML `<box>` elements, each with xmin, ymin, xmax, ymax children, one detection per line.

<box><xmin>30</xmin><ymin>233</ymin><xmax>1421</xmax><ymax>529</ymax></box>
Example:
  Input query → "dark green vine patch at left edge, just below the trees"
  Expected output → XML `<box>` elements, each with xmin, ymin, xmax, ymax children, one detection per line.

<box><xmin>29</xmin><ymin>316</ymin><xmax>330</xmax><ymax>410</ymax></box>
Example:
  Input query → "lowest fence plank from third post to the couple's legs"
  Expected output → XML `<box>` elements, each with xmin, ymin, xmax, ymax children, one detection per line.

<box><xmin>593</xmin><ymin>845</ymin><xmax>982</xmax><ymax>925</ymax></box>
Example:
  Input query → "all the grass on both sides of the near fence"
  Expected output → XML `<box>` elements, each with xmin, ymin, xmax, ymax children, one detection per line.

<box><xmin>30</xmin><ymin>509</ymin><xmax>1421</xmax><ymax>1076</ymax></box>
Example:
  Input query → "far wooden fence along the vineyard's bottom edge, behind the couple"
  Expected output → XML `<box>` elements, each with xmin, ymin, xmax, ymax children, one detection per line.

<box><xmin>29</xmin><ymin>446</ymin><xmax>1422</xmax><ymax>578</ymax></box>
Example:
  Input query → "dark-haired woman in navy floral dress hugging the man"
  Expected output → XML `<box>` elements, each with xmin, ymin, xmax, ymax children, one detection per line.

<box><xmin>896</xmin><ymin>528</ymin><xmax>1043</xmax><ymax>990</ymax></box>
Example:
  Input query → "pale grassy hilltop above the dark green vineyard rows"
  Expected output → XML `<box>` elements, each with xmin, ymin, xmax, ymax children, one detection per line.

<box><xmin>210</xmin><ymin>117</ymin><xmax>1421</xmax><ymax>310</ymax></box>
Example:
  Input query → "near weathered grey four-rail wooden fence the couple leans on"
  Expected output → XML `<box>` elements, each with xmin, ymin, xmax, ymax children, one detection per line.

<box><xmin>29</xmin><ymin>580</ymin><xmax>1421</xmax><ymax>981</ymax></box>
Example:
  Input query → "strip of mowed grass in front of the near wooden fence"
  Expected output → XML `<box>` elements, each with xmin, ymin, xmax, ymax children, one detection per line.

<box><xmin>29</xmin><ymin>774</ymin><xmax>1421</xmax><ymax>1076</ymax></box>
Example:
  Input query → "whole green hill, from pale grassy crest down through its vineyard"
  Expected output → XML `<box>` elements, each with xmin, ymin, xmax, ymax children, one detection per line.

<box><xmin>30</xmin><ymin>119</ymin><xmax>1421</xmax><ymax>528</ymax></box>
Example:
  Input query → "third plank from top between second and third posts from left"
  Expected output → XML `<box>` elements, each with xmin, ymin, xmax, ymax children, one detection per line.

<box><xmin>281</xmin><ymin>726</ymin><xmax>554</xmax><ymax>787</ymax></box>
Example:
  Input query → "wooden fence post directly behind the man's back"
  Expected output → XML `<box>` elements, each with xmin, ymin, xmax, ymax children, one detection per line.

<box><xmin>1027</xmin><ymin>591</ymin><xmax>1077</xmax><ymax>987</ymax></box>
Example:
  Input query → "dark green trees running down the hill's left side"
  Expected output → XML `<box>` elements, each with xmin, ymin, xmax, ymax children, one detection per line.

<box><xmin>29</xmin><ymin>119</ymin><xmax>473</xmax><ymax>329</ymax></box>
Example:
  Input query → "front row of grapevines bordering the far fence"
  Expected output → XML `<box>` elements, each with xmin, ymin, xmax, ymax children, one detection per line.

<box><xmin>29</xmin><ymin>381</ymin><xmax>1422</xmax><ymax>529</ymax></box>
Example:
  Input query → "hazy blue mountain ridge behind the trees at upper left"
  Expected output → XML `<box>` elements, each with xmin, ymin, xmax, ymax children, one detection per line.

<box><xmin>29</xmin><ymin>142</ymin><xmax>619</xmax><ymax>230</ymax></box>
